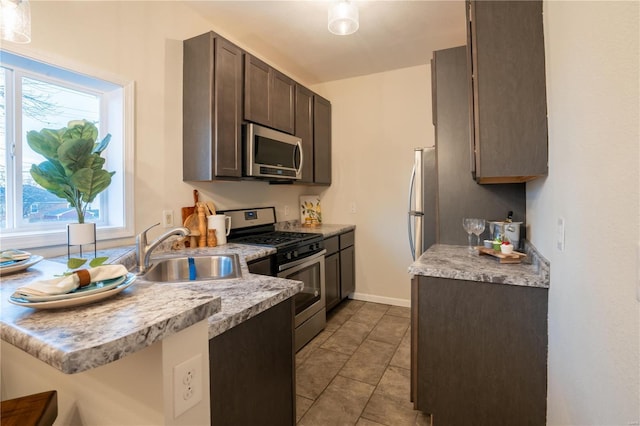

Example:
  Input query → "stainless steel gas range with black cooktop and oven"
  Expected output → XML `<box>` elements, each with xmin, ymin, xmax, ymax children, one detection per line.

<box><xmin>221</xmin><ymin>207</ymin><xmax>326</xmax><ymax>351</ymax></box>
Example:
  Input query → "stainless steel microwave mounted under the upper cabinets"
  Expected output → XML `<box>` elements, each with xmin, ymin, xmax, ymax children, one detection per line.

<box><xmin>244</xmin><ymin>123</ymin><xmax>304</xmax><ymax>180</ymax></box>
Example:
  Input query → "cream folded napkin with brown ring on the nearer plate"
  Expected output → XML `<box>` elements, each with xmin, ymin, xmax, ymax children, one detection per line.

<box><xmin>13</xmin><ymin>265</ymin><xmax>128</xmax><ymax>297</ymax></box>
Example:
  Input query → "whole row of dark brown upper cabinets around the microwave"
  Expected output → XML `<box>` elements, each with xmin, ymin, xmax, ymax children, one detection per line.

<box><xmin>182</xmin><ymin>32</ymin><xmax>331</xmax><ymax>185</ymax></box>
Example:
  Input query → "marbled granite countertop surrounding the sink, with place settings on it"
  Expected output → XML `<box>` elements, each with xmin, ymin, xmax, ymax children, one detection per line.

<box><xmin>0</xmin><ymin>244</ymin><xmax>302</xmax><ymax>374</ymax></box>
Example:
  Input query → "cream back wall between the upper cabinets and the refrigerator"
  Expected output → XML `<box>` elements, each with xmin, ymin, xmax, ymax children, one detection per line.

<box><xmin>312</xmin><ymin>65</ymin><xmax>434</xmax><ymax>306</ymax></box>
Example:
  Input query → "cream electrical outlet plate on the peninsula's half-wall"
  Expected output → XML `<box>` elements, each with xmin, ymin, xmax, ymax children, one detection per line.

<box><xmin>173</xmin><ymin>354</ymin><xmax>202</xmax><ymax>419</ymax></box>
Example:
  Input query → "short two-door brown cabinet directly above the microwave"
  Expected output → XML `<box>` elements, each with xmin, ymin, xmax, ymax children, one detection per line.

<box><xmin>244</xmin><ymin>54</ymin><xmax>296</xmax><ymax>134</ymax></box>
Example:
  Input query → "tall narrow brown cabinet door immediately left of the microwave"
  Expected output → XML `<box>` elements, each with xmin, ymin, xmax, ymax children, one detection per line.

<box><xmin>214</xmin><ymin>38</ymin><xmax>242</xmax><ymax>177</ymax></box>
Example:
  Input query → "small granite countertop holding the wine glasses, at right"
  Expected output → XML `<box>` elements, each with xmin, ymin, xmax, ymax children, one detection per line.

<box><xmin>409</xmin><ymin>244</ymin><xmax>549</xmax><ymax>288</ymax></box>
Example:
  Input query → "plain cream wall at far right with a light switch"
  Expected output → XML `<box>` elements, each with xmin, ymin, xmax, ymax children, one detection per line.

<box><xmin>527</xmin><ymin>1</ymin><xmax>640</xmax><ymax>425</ymax></box>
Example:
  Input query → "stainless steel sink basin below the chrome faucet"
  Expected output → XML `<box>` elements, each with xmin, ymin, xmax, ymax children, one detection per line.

<box><xmin>142</xmin><ymin>254</ymin><xmax>242</xmax><ymax>282</ymax></box>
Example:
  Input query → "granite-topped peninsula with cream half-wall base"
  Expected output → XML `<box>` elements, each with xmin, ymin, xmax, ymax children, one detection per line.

<box><xmin>0</xmin><ymin>244</ymin><xmax>301</xmax><ymax>425</ymax></box>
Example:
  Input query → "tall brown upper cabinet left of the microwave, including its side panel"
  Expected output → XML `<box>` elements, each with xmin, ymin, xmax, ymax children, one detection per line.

<box><xmin>182</xmin><ymin>32</ymin><xmax>243</xmax><ymax>181</ymax></box>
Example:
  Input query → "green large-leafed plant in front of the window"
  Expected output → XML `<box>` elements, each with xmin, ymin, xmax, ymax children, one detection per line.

<box><xmin>27</xmin><ymin>120</ymin><xmax>115</xmax><ymax>223</ymax></box>
